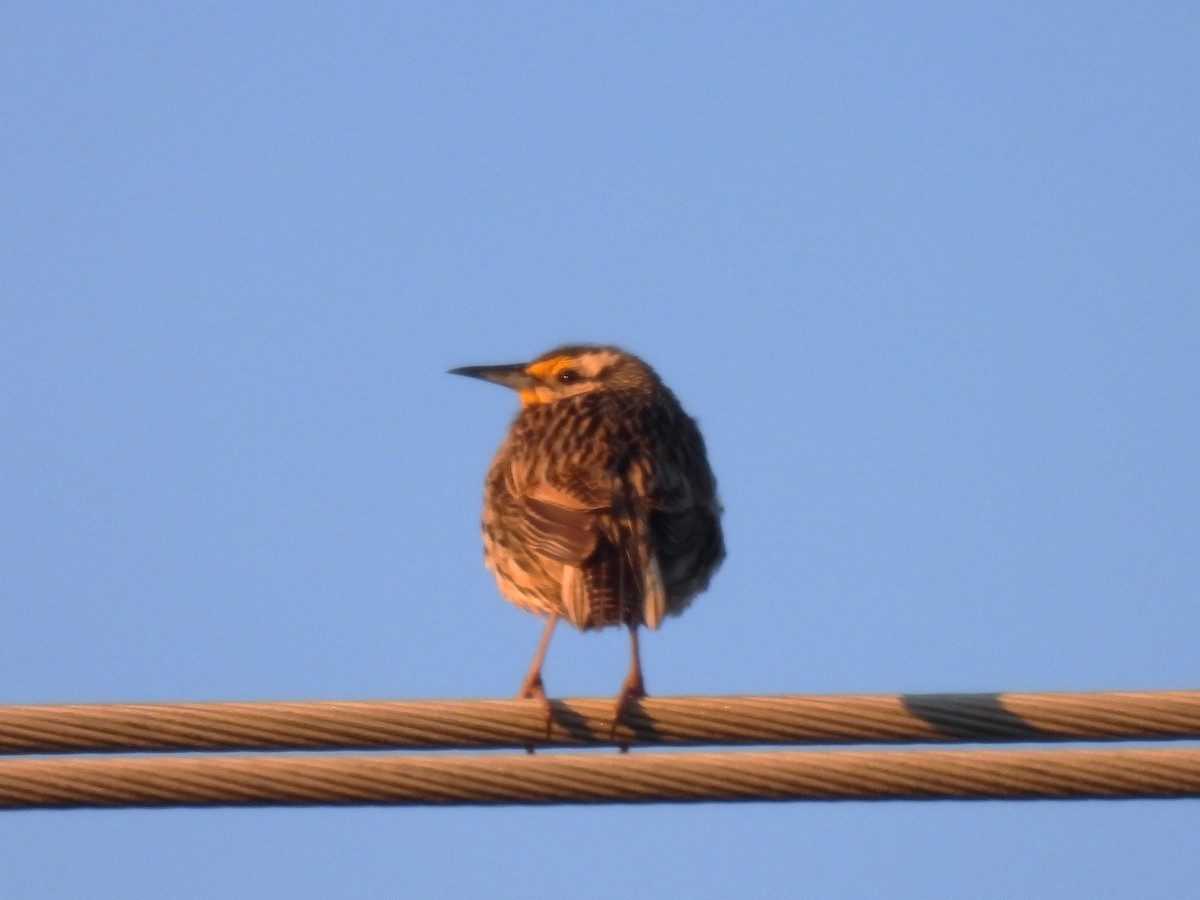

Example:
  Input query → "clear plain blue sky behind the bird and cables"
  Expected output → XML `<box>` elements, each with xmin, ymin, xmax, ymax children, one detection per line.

<box><xmin>0</xmin><ymin>2</ymin><xmax>1200</xmax><ymax>898</ymax></box>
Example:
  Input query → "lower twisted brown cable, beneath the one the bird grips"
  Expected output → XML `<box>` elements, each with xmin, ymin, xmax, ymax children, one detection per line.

<box><xmin>0</xmin><ymin>748</ymin><xmax>1200</xmax><ymax>809</ymax></box>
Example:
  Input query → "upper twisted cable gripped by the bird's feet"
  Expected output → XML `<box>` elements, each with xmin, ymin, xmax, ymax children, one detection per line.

<box><xmin>0</xmin><ymin>691</ymin><xmax>1200</xmax><ymax>755</ymax></box>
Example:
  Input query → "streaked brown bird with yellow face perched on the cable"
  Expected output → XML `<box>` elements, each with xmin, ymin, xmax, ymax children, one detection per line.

<box><xmin>450</xmin><ymin>344</ymin><xmax>725</xmax><ymax>732</ymax></box>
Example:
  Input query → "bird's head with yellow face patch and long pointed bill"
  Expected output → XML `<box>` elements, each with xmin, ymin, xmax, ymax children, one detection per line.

<box><xmin>450</xmin><ymin>344</ymin><xmax>661</xmax><ymax>407</ymax></box>
